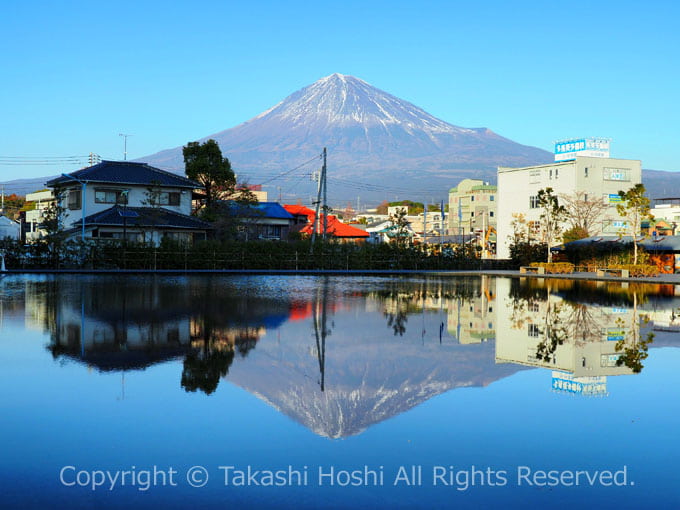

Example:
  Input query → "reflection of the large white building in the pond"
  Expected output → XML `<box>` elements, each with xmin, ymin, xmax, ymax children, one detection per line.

<box><xmin>496</xmin><ymin>279</ymin><xmax>640</xmax><ymax>377</ymax></box>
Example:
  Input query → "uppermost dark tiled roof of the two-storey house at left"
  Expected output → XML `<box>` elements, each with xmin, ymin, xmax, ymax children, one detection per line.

<box><xmin>47</xmin><ymin>161</ymin><xmax>202</xmax><ymax>189</ymax></box>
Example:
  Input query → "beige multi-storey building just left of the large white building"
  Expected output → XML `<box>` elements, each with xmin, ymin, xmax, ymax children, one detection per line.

<box><xmin>448</xmin><ymin>179</ymin><xmax>498</xmax><ymax>235</ymax></box>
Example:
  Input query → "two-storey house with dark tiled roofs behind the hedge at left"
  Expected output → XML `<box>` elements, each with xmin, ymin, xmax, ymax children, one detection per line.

<box><xmin>47</xmin><ymin>161</ymin><xmax>210</xmax><ymax>244</ymax></box>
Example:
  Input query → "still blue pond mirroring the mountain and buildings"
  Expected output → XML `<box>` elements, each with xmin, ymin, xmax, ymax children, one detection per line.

<box><xmin>0</xmin><ymin>275</ymin><xmax>680</xmax><ymax>508</ymax></box>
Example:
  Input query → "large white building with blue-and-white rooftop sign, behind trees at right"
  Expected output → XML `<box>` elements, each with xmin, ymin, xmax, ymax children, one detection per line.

<box><xmin>497</xmin><ymin>150</ymin><xmax>642</xmax><ymax>255</ymax></box>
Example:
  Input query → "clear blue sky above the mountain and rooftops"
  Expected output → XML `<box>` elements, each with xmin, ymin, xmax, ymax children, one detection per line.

<box><xmin>0</xmin><ymin>0</ymin><xmax>680</xmax><ymax>185</ymax></box>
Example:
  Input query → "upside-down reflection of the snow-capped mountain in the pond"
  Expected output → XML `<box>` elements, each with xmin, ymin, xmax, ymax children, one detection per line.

<box><xmin>227</xmin><ymin>274</ymin><xmax>522</xmax><ymax>438</ymax></box>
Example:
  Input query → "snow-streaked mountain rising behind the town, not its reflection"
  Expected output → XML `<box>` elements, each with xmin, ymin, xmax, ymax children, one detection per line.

<box><xmin>140</xmin><ymin>74</ymin><xmax>552</xmax><ymax>201</ymax></box>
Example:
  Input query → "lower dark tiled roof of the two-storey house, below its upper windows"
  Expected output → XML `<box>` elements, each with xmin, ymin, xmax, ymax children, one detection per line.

<box><xmin>73</xmin><ymin>205</ymin><xmax>212</xmax><ymax>230</ymax></box>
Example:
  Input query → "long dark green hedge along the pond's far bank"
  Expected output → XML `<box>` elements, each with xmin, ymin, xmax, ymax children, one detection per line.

<box><xmin>0</xmin><ymin>241</ymin><xmax>510</xmax><ymax>270</ymax></box>
